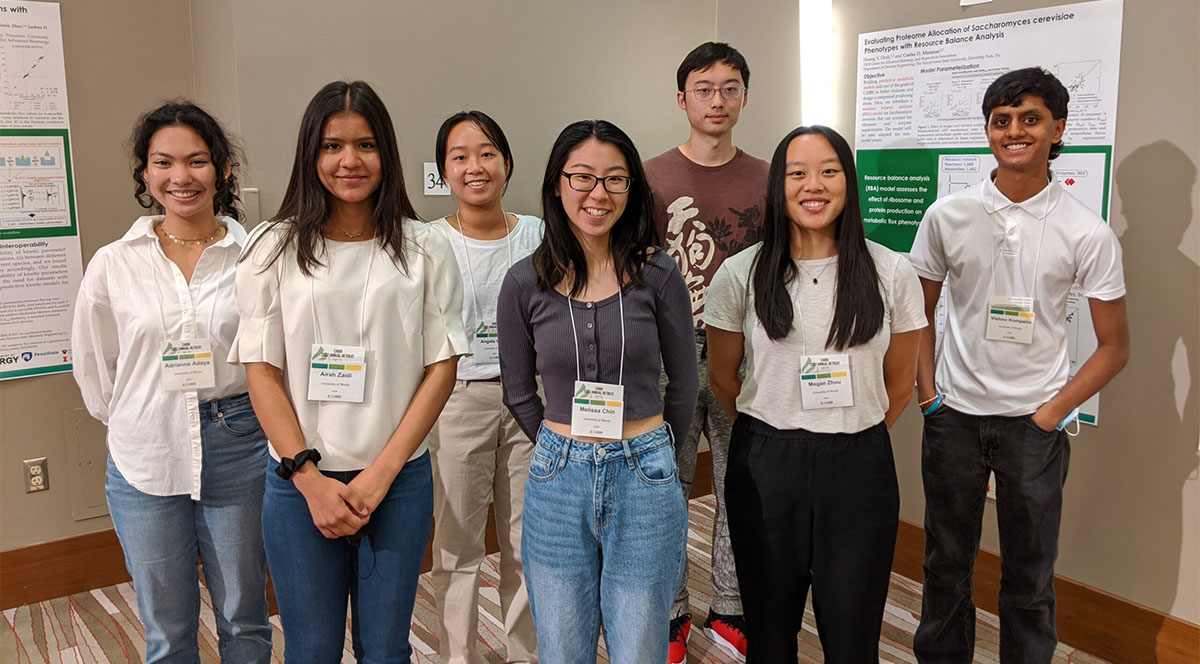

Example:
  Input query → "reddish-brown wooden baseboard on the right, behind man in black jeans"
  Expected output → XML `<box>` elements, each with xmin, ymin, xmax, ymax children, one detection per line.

<box><xmin>892</xmin><ymin>520</ymin><xmax>1200</xmax><ymax>664</ymax></box>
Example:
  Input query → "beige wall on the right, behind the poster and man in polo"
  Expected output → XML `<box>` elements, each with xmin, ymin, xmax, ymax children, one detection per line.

<box><xmin>834</xmin><ymin>0</ymin><xmax>1200</xmax><ymax>622</ymax></box>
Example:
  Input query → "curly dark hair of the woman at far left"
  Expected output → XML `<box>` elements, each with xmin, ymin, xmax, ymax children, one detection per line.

<box><xmin>130</xmin><ymin>100</ymin><xmax>242</xmax><ymax>221</ymax></box>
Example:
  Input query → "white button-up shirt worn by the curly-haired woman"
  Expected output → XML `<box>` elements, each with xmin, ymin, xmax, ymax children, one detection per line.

<box><xmin>71</xmin><ymin>216</ymin><xmax>246</xmax><ymax>500</ymax></box>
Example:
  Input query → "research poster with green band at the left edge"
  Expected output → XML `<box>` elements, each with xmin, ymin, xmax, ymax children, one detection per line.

<box><xmin>0</xmin><ymin>0</ymin><xmax>83</xmax><ymax>381</ymax></box>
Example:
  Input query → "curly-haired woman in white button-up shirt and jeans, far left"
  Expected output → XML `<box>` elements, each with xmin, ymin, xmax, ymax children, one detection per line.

<box><xmin>71</xmin><ymin>103</ymin><xmax>271</xmax><ymax>663</ymax></box>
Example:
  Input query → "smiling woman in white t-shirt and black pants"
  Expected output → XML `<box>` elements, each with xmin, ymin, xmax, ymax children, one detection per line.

<box><xmin>704</xmin><ymin>126</ymin><xmax>925</xmax><ymax>663</ymax></box>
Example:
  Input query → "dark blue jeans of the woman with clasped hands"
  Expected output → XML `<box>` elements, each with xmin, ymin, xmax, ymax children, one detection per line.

<box><xmin>263</xmin><ymin>454</ymin><xmax>433</xmax><ymax>664</ymax></box>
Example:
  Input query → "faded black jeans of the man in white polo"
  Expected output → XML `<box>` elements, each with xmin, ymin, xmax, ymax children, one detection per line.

<box><xmin>913</xmin><ymin>406</ymin><xmax>1070</xmax><ymax>664</ymax></box>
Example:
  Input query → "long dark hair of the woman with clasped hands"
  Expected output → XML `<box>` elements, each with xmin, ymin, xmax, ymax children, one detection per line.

<box><xmin>255</xmin><ymin>80</ymin><xmax>419</xmax><ymax>276</ymax></box>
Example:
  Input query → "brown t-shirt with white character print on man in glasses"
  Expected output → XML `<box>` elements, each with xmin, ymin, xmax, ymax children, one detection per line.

<box><xmin>643</xmin><ymin>148</ymin><xmax>770</xmax><ymax>328</ymax></box>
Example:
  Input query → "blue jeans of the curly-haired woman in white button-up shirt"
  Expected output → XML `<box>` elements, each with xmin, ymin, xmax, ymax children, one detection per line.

<box><xmin>104</xmin><ymin>394</ymin><xmax>271</xmax><ymax>664</ymax></box>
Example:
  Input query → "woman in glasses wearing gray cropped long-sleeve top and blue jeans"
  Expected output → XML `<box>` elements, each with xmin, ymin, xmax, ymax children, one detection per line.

<box><xmin>498</xmin><ymin>120</ymin><xmax>697</xmax><ymax>664</ymax></box>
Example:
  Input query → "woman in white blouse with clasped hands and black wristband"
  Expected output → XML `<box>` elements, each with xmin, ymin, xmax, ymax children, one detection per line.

<box><xmin>229</xmin><ymin>82</ymin><xmax>469</xmax><ymax>663</ymax></box>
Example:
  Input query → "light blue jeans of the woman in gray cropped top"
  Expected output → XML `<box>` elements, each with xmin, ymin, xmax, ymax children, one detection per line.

<box><xmin>521</xmin><ymin>424</ymin><xmax>688</xmax><ymax>664</ymax></box>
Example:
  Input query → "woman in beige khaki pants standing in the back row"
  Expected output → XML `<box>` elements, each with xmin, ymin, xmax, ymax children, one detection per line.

<box><xmin>431</xmin><ymin>110</ymin><xmax>542</xmax><ymax>664</ymax></box>
